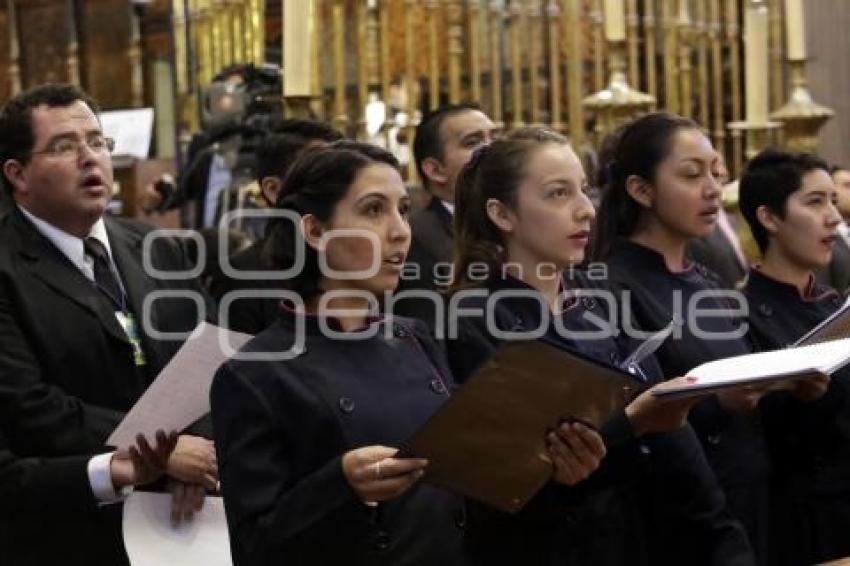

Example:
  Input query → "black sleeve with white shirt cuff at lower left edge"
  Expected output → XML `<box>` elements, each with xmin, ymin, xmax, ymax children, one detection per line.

<box><xmin>0</xmin><ymin>435</ymin><xmax>96</xmax><ymax>519</ymax></box>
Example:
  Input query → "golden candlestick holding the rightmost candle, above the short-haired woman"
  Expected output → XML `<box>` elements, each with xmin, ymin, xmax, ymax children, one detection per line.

<box><xmin>770</xmin><ymin>59</ymin><xmax>835</xmax><ymax>153</ymax></box>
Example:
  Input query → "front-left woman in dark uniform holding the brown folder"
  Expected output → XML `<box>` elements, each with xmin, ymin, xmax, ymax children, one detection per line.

<box><xmin>211</xmin><ymin>142</ymin><xmax>592</xmax><ymax>566</ymax></box>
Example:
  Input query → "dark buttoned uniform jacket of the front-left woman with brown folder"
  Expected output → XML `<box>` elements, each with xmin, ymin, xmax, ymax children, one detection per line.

<box><xmin>211</xmin><ymin>310</ymin><xmax>464</xmax><ymax>566</ymax></box>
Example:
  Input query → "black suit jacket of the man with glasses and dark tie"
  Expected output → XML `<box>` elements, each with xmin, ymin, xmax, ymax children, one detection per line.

<box><xmin>0</xmin><ymin>209</ymin><xmax>210</xmax><ymax>564</ymax></box>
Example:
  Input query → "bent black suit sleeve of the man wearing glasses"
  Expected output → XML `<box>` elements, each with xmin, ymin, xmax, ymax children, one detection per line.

<box><xmin>0</xmin><ymin>292</ymin><xmax>124</xmax><ymax>455</ymax></box>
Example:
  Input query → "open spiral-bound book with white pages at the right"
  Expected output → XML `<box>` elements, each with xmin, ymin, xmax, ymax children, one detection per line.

<box><xmin>652</xmin><ymin>338</ymin><xmax>850</xmax><ymax>397</ymax></box>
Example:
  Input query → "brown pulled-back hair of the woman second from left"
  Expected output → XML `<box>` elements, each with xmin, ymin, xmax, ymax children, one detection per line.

<box><xmin>450</xmin><ymin>128</ymin><xmax>567</xmax><ymax>292</ymax></box>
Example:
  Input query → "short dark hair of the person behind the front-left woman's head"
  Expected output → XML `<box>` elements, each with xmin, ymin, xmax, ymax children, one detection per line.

<box><xmin>256</xmin><ymin>119</ymin><xmax>342</xmax><ymax>181</ymax></box>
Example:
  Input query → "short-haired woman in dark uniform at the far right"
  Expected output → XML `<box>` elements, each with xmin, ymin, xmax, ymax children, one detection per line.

<box><xmin>740</xmin><ymin>150</ymin><xmax>850</xmax><ymax>565</ymax></box>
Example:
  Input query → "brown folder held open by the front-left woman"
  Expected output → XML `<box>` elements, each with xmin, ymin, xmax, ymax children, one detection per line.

<box><xmin>404</xmin><ymin>341</ymin><xmax>643</xmax><ymax>513</ymax></box>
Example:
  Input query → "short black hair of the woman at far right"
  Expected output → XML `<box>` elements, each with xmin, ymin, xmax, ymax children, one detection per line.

<box><xmin>738</xmin><ymin>149</ymin><xmax>829</xmax><ymax>254</ymax></box>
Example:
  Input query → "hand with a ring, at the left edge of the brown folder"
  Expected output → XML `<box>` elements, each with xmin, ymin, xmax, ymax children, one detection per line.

<box><xmin>342</xmin><ymin>446</ymin><xmax>428</xmax><ymax>502</ymax></box>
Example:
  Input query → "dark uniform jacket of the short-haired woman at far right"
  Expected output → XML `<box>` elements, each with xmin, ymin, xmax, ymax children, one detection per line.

<box><xmin>744</xmin><ymin>269</ymin><xmax>850</xmax><ymax>565</ymax></box>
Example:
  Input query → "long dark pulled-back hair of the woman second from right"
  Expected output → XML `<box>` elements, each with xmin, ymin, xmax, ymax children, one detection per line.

<box><xmin>590</xmin><ymin>112</ymin><xmax>699</xmax><ymax>261</ymax></box>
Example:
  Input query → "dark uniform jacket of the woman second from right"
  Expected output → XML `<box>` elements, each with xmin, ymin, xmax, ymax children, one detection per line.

<box><xmin>607</xmin><ymin>240</ymin><xmax>770</xmax><ymax>562</ymax></box>
